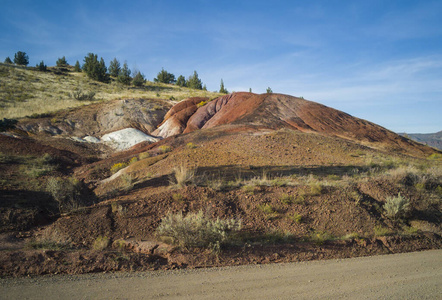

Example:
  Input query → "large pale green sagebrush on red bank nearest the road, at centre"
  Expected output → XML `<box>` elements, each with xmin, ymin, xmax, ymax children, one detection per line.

<box><xmin>156</xmin><ymin>211</ymin><xmax>241</xmax><ymax>248</ymax></box>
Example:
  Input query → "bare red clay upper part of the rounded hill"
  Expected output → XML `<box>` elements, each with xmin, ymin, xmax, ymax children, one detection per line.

<box><xmin>153</xmin><ymin>92</ymin><xmax>431</xmax><ymax>156</ymax></box>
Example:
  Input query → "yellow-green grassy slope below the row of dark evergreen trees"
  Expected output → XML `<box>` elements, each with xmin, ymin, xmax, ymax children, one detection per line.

<box><xmin>0</xmin><ymin>64</ymin><xmax>220</xmax><ymax>119</ymax></box>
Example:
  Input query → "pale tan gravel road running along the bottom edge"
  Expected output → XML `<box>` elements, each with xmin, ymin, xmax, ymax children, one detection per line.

<box><xmin>0</xmin><ymin>250</ymin><xmax>442</xmax><ymax>299</ymax></box>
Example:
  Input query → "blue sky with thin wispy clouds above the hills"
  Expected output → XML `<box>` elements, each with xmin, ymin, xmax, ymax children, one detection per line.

<box><xmin>0</xmin><ymin>0</ymin><xmax>442</xmax><ymax>133</ymax></box>
